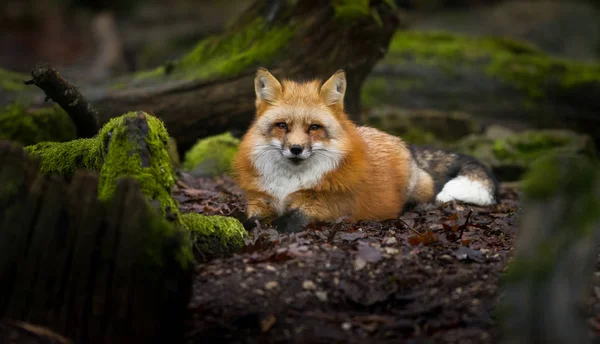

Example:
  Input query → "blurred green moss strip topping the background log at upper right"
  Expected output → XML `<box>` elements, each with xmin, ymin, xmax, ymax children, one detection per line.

<box><xmin>385</xmin><ymin>30</ymin><xmax>600</xmax><ymax>100</ymax></box>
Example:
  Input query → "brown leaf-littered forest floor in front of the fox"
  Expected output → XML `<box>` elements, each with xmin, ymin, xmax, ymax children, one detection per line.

<box><xmin>174</xmin><ymin>176</ymin><xmax>519</xmax><ymax>343</ymax></box>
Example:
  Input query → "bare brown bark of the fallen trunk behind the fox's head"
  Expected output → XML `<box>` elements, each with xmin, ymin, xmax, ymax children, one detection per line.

<box><xmin>88</xmin><ymin>0</ymin><xmax>399</xmax><ymax>152</ymax></box>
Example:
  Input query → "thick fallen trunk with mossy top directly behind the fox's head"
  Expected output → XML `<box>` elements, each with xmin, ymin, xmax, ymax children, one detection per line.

<box><xmin>3</xmin><ymin>0</ymin><xmax>399</xmax><ymax>154</ymax></box>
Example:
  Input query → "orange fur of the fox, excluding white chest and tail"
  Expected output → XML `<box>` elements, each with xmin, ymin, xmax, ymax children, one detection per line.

<box><xmin>233</xmin><ymin>69</ymin><xmax>433</xmax><ymax>221</ymax></box>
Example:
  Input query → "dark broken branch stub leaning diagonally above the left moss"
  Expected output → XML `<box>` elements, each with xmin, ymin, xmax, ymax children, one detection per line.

<box><xmin>24</xmin><ymin>64</ymin><xmax>99</xmax><ymax>138</ymax></box>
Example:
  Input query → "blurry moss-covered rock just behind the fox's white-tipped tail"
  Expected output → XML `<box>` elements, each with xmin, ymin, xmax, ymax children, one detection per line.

<box><xmin>454</xmin><ymin>126</ymin><xmax>596</xmax><ymax>181</ymax></box>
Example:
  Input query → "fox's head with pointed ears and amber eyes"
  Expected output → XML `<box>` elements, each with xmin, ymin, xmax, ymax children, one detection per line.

<box><xmin>254</xmin><ymin>68</ymin><xmax>348</xmax><ymax>169</ymax></box>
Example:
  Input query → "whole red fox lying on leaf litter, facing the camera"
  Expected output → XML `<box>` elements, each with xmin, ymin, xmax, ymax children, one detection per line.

<box><xmin>233</xmin><ymin>68</ymin><xmax>498</xmax><ymax>231</ymax></box>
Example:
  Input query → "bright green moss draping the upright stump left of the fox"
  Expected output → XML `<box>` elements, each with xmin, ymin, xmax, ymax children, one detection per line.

<box><xmin>96</xmin><ymin>112</ymin><xmax>179</xmax><ymax>221</ymax></box>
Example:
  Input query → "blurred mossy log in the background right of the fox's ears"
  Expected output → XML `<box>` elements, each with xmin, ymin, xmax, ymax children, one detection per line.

<box><xmin>362</xmin><ymin>30</ymin><xmax>600</xmax><ymax>147</ymax></box>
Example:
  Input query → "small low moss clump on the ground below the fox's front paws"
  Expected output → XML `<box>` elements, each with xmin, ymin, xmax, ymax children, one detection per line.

<box><xmin>181</xmin><ymin>213</ymin><xmax>247</xmax><ymax>258</ymax></box>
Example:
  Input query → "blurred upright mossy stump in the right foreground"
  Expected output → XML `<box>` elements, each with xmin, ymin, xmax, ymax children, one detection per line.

<box><xmin>498</xmin><ymin>155</ymin><xmax>600</xmax><ymax>344</ymax></box>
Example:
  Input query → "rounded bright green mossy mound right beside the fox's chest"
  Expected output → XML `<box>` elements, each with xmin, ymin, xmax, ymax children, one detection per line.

<box><xmin>183</xmin><ymin>132</ymin><xmax>240</xmax><ymax>177</ymax></box>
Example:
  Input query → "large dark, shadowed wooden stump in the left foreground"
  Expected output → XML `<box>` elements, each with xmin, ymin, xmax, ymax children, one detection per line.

<box><xmin>0</xmin><ymin>141</ymin><xmax>193</xmax><ymax>343</ymax></box>
